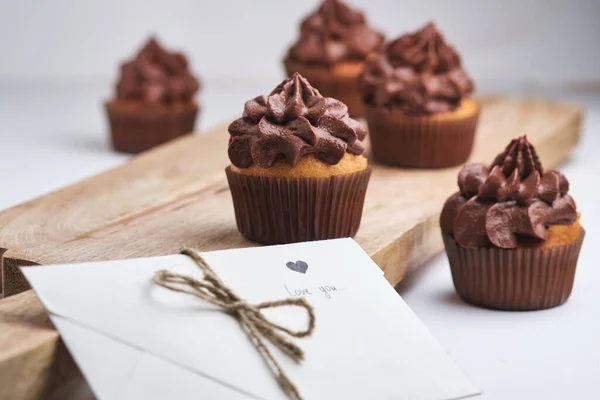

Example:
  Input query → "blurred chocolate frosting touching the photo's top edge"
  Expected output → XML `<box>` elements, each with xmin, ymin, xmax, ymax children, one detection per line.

<box><xmin>288</xmin><ymin>0</ymin><xmax>384</xmax><ymax>66</ymax></box>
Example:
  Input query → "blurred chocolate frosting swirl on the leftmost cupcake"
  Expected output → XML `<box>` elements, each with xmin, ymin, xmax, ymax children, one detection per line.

<box><xmin>117</xmin><ymin>38</ymin><xmax>200</xmax><ymax>103</ymax></box>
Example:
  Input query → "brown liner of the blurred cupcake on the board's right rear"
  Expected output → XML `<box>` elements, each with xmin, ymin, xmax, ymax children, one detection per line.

<box><xmin>365</xmin><ymin>105</ymin><xmax>479</xmax><ymax>168</ymax></box>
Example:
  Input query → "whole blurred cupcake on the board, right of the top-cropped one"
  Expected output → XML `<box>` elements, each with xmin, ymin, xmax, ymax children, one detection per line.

<box><xmin>359</xmin><ymin>23</ymin><xmax>479</xmax><ymax>168</ymax></box>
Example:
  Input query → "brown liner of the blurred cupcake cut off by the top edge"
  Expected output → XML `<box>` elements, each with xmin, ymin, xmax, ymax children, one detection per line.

<box><xmin>284</xmin><ymin>59</ymin><xmax>364</xmax><ymax>118</ymax></box>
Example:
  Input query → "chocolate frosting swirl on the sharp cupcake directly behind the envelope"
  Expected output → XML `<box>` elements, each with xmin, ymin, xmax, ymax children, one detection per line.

<box><xmin>228</xmin><ymin>73</ymin><xmax>367</xmax><ymax>168</ymax></box>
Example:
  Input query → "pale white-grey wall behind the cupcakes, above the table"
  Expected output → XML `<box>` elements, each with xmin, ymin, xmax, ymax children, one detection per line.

<box><xmin>0</xmin><ymin>0</ymin><xmax>600</xmax><ymax>84</ymax></box>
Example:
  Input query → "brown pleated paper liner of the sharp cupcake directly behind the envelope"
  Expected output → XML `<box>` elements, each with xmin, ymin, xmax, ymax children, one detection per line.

<box><xmin>225</xmin><ymin>167</ymin><xmax>371</xmax><ymax>244</ymax></box>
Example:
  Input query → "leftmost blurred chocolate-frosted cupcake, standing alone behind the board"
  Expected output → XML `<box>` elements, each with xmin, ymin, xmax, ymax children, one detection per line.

<box><xmin>106</xmin><ymin>38</ymin><xmax>200</xmax><ymax>153</ymax></box>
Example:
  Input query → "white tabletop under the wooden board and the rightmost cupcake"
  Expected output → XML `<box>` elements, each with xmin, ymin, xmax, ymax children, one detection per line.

<box><xmin>0</xmin><ymin>79</ymin><xmax>600</xmax><ymax>400</ymax></box>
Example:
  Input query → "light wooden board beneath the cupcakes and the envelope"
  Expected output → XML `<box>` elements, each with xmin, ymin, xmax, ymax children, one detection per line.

<box><xmin>0</xmin><ymin>97</ymin><xmax>582</xmax><ymax>399</ymax></box>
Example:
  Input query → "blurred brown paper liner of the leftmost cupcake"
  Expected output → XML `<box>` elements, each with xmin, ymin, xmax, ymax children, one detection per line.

<box><xmin>106</xmin><ymin>102</ymin><xmax>198</xmax><ymax>154</ymax></box>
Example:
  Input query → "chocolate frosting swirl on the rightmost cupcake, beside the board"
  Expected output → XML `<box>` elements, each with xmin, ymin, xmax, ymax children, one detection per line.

<box><xmin>440</xmin><ymin>136</ymin><xmax>577</xmax><ymax>249</ymax></box>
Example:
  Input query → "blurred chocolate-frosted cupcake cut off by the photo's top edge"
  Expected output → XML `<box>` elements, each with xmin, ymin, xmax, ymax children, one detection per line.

<box><xmin>284</xmin><ymin>0</ymin><xmax>384</xmax><ymax>118</ymax></box>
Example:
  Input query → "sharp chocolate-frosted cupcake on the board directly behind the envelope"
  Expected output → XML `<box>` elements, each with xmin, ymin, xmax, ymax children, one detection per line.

<box><xmin>225</xmin><ymin>73</ymin><xmax>371</xmax><ymax>244</ymax></box>
